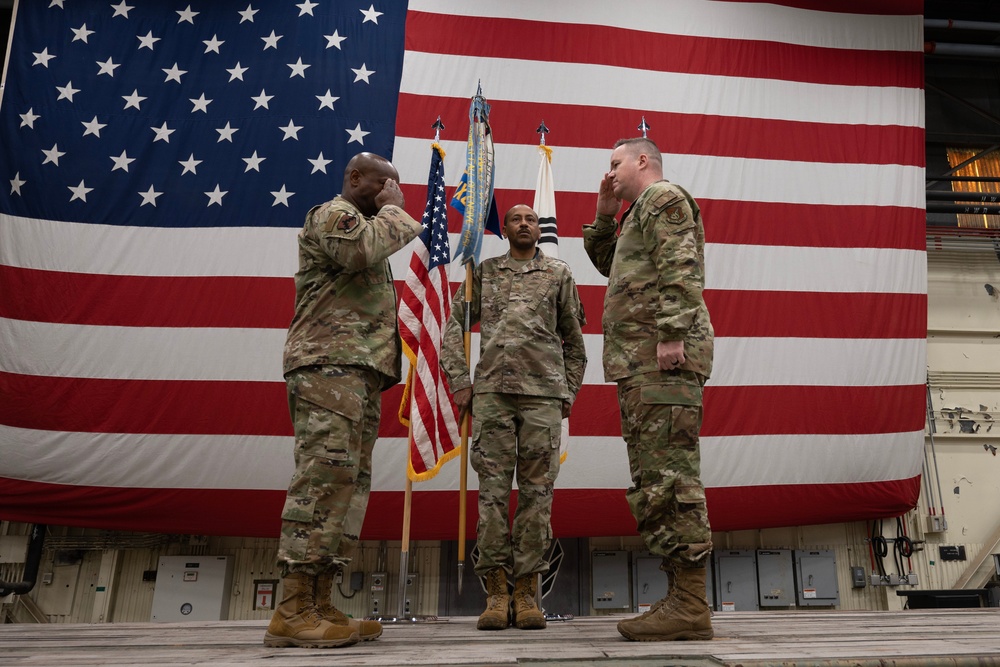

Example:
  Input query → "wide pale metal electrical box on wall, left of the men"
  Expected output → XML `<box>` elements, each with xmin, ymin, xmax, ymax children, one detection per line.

<box><xmin>149</xmin><ymin>556</ymin><xmax>233</xmax><ymax>623</ymax></box>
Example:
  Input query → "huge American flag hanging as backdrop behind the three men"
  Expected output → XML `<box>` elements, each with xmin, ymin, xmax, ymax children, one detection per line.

<box><xmin>0</xmin><ymin>0</ymin><xmax>927</xmax><ymax>539</ymax></box>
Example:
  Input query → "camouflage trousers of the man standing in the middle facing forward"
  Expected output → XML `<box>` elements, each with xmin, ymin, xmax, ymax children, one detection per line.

<box><xmin>469</xmin><ymin>393</ymin><xmax>562</xmax><ymax>577</ymax></box>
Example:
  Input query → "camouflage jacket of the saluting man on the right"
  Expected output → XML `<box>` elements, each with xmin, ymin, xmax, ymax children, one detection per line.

<box><xmin>583</xmin><ymin>181</ymin><xmax>714</xmax><ymax>382</ymax></box>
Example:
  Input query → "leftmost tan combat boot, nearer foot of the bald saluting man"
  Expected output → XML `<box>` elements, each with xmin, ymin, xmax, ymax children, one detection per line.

<box><xmin>264</xmin><ymin>572</ymin><xmax>358</xmax><ymax>648</ymax></box>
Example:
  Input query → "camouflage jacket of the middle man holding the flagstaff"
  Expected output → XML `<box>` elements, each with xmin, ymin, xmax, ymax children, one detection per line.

<box><xmin>441</xmin><ymin>250</ymin><xmax>587</xmax><ymax>403</ymax></box>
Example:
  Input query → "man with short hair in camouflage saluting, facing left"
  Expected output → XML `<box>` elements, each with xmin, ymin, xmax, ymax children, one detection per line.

<box><xmin>583</xmin><ymin>138</ymin><xmax>714</xmax><ymax>641</ymax></box>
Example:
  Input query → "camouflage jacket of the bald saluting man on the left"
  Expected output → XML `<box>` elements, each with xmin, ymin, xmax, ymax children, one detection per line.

<box><xmin>284</xmin><ymin>196</ymin><xmax>423</xmax><ymax>388</ymax></box>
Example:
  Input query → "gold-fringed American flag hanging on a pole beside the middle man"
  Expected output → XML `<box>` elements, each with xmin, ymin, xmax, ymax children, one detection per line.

<box><xmin>399</xmin><ymin>144</ymin><xmax>461</xmax><ymax>482</ymax></box>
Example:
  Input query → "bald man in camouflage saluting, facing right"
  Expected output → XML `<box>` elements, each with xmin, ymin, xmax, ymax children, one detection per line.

<box><xmin>264</xmin><ymin>153</ymin><xmax>423</xmax><ymax>647</ymax></box>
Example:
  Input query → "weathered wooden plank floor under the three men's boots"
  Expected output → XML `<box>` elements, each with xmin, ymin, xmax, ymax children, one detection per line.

<box><xmin>0</xmin><ymin>609</ymin><xmax>1000</xmax><ymax>667</ymax></box>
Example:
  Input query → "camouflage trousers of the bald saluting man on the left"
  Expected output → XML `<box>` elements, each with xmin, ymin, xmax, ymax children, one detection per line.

<box><xmin>277</xmin><ymin>366</ymin><xmax>382</xmax><ymax>577</ymax></box>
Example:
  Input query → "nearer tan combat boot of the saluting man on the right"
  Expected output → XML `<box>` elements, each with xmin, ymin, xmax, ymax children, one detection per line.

<box><xmin>618</xmin><ymin>567</ymin><xmax>715</xmax><ymax>642</ymax></box>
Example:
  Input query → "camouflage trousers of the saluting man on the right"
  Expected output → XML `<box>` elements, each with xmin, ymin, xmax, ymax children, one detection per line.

<box><xmin>618</xmin><ymin>371</ymin><xmax>712</xmax><ymax>567</ymax></box>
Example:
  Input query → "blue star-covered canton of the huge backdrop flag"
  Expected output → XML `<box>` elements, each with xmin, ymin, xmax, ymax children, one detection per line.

<box><xmin>0</xmin><ymin>0</ymin><xmax>406</xmax><ymax>227</ymax></box>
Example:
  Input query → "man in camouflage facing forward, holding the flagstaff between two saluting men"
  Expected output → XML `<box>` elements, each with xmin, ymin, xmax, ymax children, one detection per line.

<box><xmin>441</xmin><ymin>204</ymin><xmax>587</xmax><ymax>630</ymax></box>
